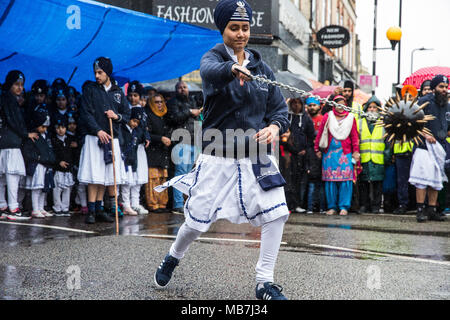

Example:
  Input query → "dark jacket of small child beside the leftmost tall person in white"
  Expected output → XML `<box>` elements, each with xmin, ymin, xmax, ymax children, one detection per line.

<box><xmin>22</xmin><ymin>134</ymin><xmax>56</xmax><ymax>176</ymax></box>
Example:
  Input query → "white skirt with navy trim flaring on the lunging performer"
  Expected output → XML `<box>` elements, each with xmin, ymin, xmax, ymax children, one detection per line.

<box><xmin>155</xmin><ymin>154</ymin><xmax>289</xmax><ymax>232</ymax></box>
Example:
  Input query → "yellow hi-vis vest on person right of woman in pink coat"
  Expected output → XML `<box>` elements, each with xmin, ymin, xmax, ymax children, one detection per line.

<box><xmin>357</xmin><ymin>118</ymin><xmax>385</xmax><ymax>165</ymax></box>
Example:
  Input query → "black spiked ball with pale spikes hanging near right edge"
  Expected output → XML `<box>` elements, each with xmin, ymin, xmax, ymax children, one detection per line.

<box><xmin>377</xmin><ymin>93</ymin><xmax>434</xmax><ymax>146</ymax></box>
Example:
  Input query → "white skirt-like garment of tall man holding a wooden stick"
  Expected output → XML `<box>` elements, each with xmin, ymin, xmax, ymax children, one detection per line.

<box><xmin>78</xmin><ymin>135</ymin><xmax>126</xmax><ymax>186</ymax></box>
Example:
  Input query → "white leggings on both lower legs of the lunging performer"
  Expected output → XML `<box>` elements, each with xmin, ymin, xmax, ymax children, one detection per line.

<box><xmin>169</xmin><ymin>217</ymin><xmax>286</xmax><ymax>282</ymax></box>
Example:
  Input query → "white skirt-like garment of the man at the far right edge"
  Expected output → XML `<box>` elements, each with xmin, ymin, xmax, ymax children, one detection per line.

<box><xmin>408</xmin><ymin>141</ymin><xmax>448</xmax><ymax>191</ymax></box>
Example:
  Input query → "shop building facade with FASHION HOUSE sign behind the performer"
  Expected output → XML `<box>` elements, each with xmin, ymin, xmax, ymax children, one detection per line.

<box><xmin>96</xmin><ymin>0</ymin><xmax>361</xmax><ymax>84</ymax></box>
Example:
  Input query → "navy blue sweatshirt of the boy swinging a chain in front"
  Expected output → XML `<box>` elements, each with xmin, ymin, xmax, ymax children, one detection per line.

<box><xmin>200</xmin><ymin>43</ymin><xmax>289</xmax><ymax>155</ymax></box>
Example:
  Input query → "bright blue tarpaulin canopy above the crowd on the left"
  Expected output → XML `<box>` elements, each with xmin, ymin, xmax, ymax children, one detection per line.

<box><xmin>0</xmin><ymin>0</ymin><xmax>222</xmax><ymax>90</ymax></box>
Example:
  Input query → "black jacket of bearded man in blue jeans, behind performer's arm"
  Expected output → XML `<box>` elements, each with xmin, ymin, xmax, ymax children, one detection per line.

<box><xmin>167</xmin><ymin>94</ymin><xmax>200</xmax><ymax>145</ymax></box>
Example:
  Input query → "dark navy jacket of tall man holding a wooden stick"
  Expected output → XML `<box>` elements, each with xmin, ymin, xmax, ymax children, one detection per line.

<box><xmin>79</xmin><ymin>82</ymin><xmax>130</xmax><ymax>140</ymax></box>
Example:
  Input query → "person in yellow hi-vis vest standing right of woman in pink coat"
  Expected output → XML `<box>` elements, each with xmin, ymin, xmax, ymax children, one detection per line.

<box><xmin>356</xmin><ymin>96</ymin><xmax>389</xmax><ymax>213</ymax></box>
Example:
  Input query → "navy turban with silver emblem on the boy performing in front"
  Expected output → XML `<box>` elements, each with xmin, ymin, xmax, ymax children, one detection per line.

<box><xmin>214</xmin><ymin>0</ymin><xmax>253</xmax><ymax>34</ymax></box>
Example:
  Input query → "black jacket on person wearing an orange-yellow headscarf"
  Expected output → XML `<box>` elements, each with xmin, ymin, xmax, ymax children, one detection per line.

<box><xmin>145</xmin><ymin>108</ymin><xmax>171</xmax><ymax>169</ymax></box>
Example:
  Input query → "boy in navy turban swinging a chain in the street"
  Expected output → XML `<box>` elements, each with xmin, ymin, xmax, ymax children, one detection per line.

<box><xmin>155</xmin><ymin>0</ymin><xmax>289</xmax><ymax>300</ymax></box>
